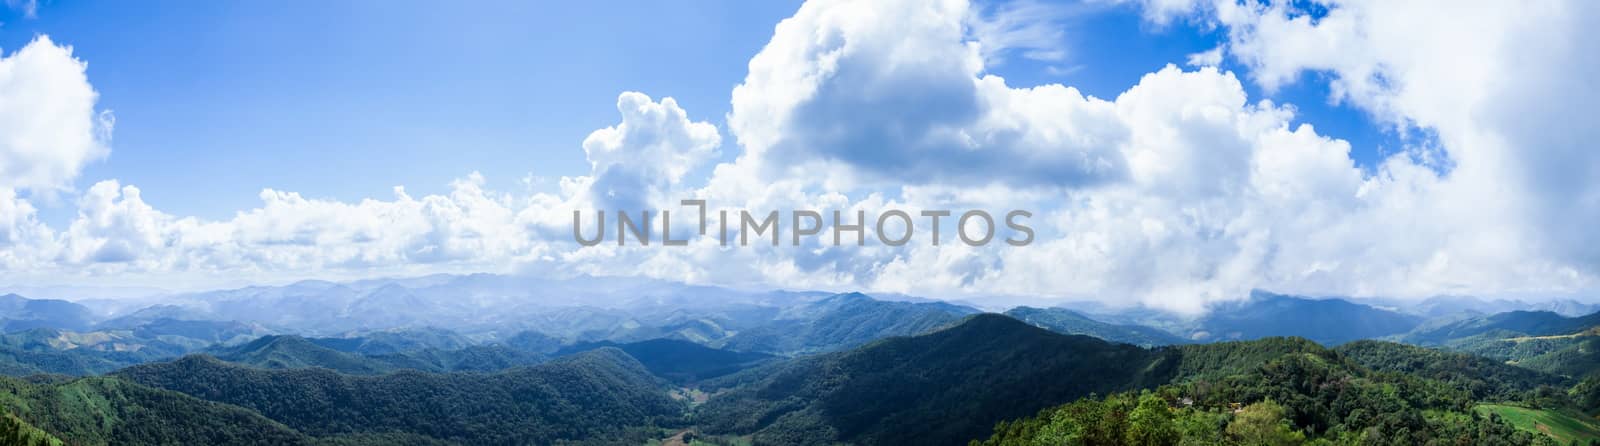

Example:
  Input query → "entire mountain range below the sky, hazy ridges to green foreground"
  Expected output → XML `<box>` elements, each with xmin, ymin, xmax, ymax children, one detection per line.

<box><xmin>0</xmin><ymin>275</ymin><xmax>1600</xmax><ymax>444</ymax></box>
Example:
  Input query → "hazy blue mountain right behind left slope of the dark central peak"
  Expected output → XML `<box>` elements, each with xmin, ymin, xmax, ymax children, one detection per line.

<box><xmin>722</xmin><ymin>293</ymin><xmax>978</xmax><ymax>355</ymax></box>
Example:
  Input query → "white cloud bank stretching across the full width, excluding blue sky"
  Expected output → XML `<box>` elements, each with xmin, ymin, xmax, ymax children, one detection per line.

<box><xmin>0</xmin><ymin>0</ymin><xmax>1600</xmax><ymax>310</ymax></box>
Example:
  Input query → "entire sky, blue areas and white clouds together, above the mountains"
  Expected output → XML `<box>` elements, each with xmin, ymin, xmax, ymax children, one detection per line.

<box><xmin>0</xmin><ymin>0</ymin><xmax>1600</xmax><ymax>310</ymax></box>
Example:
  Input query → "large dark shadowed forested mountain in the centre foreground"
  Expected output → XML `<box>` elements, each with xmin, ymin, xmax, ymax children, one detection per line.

<box><xmin>696</xmin><ymin>313</ymin><xmax>1173</xmax><ymax>444</ymax></box>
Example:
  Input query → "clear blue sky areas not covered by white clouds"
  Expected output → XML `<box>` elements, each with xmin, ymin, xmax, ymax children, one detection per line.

<box><xmin>0</xmin><ymin>2</ymin><xmax>1394</xmax><ymax>224</ymax></box>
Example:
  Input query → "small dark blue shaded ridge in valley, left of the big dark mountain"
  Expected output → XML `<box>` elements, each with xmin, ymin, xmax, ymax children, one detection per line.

<box><xmin>555</xmin><ymin>339</ymin><xmax>776</xmax><ymax>384</ymax></box>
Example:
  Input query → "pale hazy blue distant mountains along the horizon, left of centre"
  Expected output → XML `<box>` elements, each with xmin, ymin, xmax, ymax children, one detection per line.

<box><xmin>120</xmin><ymin>273</ymin><xmax>811</xmax><ymax>342</ymax></box>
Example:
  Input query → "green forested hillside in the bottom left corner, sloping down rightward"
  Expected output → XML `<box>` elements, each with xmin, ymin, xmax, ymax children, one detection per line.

<box><xmin>0</xmin><ymin>377</ymin><xmax>310</xmax><ymax>444</ymax></box>
